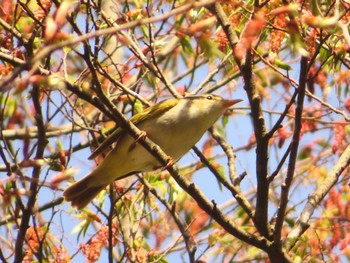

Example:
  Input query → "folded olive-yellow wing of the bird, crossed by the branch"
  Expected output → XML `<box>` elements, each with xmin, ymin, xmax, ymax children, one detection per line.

<box><xmin>89</xmin><ymin>99</ymin><xmax>177</xmax><ymax>160</ymax></box>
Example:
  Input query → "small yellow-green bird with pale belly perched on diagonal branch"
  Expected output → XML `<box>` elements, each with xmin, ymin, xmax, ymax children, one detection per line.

<box><xmin>63</xmin><ymin>94</ymin><xmax>241</xmax><ymax>209</ymax></box>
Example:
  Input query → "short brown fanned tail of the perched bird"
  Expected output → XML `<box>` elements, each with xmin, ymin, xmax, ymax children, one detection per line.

<box><xmin>63</xmin><ymin>176</ymin><xmax>107</xmax><ymax>210</ymax></box>
